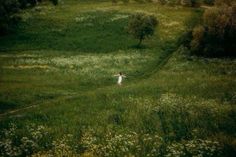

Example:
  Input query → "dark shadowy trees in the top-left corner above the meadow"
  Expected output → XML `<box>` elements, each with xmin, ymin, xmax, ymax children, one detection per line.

<box><xmin>0</xmin><ymin>0</ymin><xmax>58</xmax><ymax>35</ymax></box>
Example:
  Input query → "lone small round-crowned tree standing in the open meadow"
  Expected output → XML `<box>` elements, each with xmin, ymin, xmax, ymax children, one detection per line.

<box><xmin>127</xmin><ymin>13</ymin><xmax>158</xmax><ymax>46</ymax></box>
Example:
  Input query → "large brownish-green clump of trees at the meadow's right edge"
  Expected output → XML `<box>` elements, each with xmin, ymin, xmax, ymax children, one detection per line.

<box><xmin>182</xmin><ymin>0</ymin><xmax>236</xmax><ymax>57</ymax></box>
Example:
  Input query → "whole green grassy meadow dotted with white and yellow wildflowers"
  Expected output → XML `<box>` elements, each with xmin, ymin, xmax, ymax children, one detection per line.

<box><xmin>0</xmin><ymin>0</ymin><xmax>236</xmax><ymax>157</ymax></box>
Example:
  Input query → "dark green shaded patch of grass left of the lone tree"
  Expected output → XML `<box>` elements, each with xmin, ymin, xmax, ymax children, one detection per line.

<box><xmin>0</xmin><ymin>11</ymin><xmax>142</xmax><ymax>53</ymax></box>
